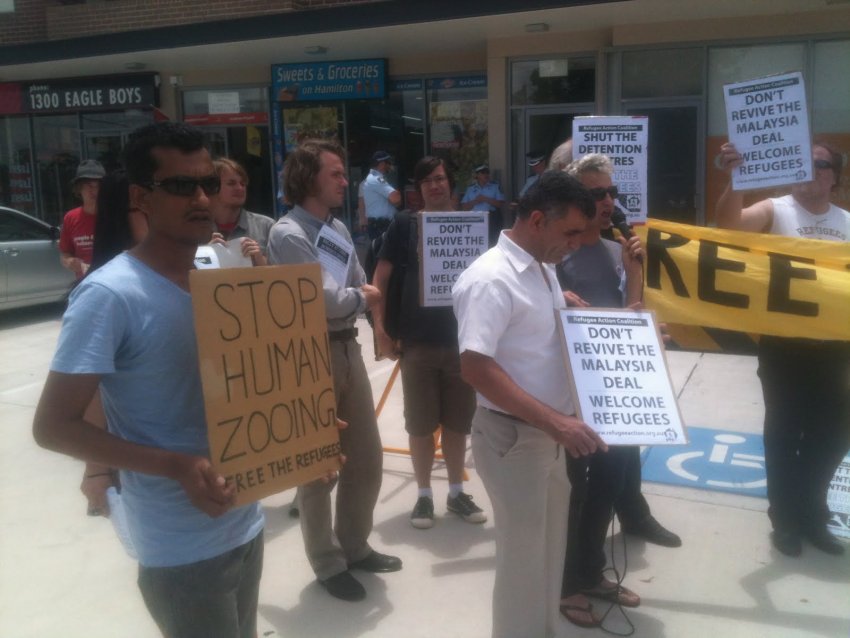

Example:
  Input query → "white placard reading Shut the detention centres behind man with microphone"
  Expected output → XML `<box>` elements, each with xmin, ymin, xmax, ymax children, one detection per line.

<box><xmin>573</xmin><ymin>115</ymin><xmax>649</xmax><ymax>224</ymax></box>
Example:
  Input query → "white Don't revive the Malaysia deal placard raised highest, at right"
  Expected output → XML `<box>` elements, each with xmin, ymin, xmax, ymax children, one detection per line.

<box><xmin>723</xmin><ymin>72</ymin><xmax>812</xmax><ymax>190</ymax></box>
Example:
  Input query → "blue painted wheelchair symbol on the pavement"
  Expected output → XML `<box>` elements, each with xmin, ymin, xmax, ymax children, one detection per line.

<box><xmin>643</xmin><ymin>427</ymin><xmax>767</xmax><ymax>497</ymax></box>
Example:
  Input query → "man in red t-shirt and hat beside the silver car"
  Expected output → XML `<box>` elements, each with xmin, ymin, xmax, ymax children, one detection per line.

<box><xmin>59</xmin><ymin>160</ymin><xmax>106</xmax><ymax>279</ymax></box>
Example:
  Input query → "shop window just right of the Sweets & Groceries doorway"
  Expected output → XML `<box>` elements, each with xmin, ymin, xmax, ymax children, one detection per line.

<box><xmin>427</xmin><ymin>77</ymin><xmax>489</xmax><ymax>193</ymax></box>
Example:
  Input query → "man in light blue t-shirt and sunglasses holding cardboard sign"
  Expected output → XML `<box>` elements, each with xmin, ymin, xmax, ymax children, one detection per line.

<box><xmin>33</xmin><ymin>122</ymin><xmax>263</xmax><ymax>638</ymax></box>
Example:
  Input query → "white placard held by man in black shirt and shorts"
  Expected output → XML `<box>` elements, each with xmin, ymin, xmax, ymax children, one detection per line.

<box><xmin>418</xmin><ymin>211</ymin><xmax>488</xmax><ymax>307</ymax></box>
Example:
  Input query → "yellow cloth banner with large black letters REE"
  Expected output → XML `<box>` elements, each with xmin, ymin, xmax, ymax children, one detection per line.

<box><xmin>635</xmin><ymin>219</ymin><xmax>850</xmax><ymax>341</ymax></box>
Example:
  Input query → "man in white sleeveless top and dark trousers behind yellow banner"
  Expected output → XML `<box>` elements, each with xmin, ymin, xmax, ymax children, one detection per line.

<box><xmin>716</xmin><ymin>142</ymin><xmax>850</xmax><ymax>556</ymax></box>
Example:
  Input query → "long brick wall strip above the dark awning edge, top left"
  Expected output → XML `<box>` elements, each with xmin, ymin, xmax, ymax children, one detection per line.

<box><xmin>42</xmin><ymin>0</ymin><xmax>380</xmax><ymax>40</ymax></box>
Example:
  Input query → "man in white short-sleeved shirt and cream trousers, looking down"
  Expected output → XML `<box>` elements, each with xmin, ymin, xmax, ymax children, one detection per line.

<box><xmin>452</xmin><ymin>172</ymin><xmax>606</xmax><ymax>637</ymax></box>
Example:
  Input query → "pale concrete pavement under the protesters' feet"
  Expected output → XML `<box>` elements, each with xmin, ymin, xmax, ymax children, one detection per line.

<box><xmin>0</xmin><ymin>308</ymin><xmax>850</xmax><ymax>638</ymax></box>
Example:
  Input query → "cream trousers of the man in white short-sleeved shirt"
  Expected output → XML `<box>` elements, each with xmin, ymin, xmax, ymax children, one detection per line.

<box><xmin>472</xmin><ymin>407</ymin><xmax>570</xmax><ymax>638</ymax></box>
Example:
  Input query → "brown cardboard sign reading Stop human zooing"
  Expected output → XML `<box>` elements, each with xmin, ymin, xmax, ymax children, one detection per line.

<box><xmin>189</xmin><ymin>264</ymin><xmax>340</xmax><ymax>505</ymax></box>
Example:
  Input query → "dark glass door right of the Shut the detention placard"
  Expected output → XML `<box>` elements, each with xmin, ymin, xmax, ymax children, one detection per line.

<box><xmin>625</xmin><ymin>99</ymin><xmax>705</xmax><ymax>225</ymax></box>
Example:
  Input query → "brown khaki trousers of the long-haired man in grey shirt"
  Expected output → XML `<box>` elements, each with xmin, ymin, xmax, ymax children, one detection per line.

<box><xmin>298</xmin><ymin>339</ymin><xmax>384</xmax><ymax>580</ymax></box>
